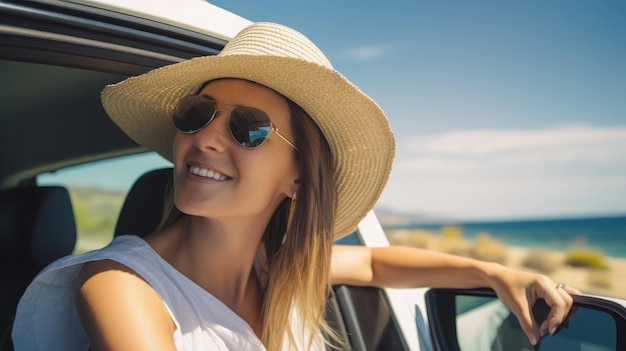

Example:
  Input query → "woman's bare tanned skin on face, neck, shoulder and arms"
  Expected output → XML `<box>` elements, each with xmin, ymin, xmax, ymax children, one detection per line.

<box><xmin>77</xmin><ymin>79</ymin><xmax>578</xmax><ymax>351</ymax></box>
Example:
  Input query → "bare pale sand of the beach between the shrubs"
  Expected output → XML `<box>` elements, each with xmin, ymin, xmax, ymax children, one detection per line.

<box><xmin>387</xmin><ymin>230</ymin><xmax>626</xmax><ymax>299</ymax></box>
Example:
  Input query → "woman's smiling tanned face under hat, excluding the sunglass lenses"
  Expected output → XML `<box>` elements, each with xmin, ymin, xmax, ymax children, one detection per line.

<box><xmin>173</xmin><ymin>79</ymin><xmax>298</xmax><ymax>218</ymax></box>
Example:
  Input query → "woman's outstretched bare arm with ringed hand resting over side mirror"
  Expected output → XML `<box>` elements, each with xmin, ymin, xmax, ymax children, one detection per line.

<box><xmin>331</xmin><ymin>245</ymin><xmax>579</xmax><ymax>344</ymax></box>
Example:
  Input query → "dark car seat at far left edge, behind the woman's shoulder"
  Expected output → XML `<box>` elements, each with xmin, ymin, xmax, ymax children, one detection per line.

<box><xmin>0</xmin><ymin>186</ymin><xmax>76</xmax><ymax>351</ymax></box>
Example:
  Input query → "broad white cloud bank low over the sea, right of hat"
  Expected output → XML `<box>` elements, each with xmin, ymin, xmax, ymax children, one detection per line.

<box><xmin>379</xmin><ymin>126</ymin><xmax>626</xmax><ymax>218</ymax></box>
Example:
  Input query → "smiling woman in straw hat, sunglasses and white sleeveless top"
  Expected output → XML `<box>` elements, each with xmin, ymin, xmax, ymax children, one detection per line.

<box><xmin>13</xmin><ymin>23</ymin><xmax>576</xmax><ymax>350</ymax></box>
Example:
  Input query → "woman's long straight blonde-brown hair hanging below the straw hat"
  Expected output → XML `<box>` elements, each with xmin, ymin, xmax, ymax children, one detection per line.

<box><xmin>157</xmin><ymin>99</ymin><xmax>341</xmax><ymax>351</ymax></box>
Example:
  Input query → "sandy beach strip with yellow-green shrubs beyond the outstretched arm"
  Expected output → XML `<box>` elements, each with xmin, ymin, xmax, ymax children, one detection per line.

<box><xmin>386</xmin><ymin>226</ymin><xmax>626</xmax><ymax>298</ymax></box>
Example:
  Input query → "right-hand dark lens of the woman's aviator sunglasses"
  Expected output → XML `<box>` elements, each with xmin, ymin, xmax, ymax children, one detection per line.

<box><xmin>229</xmin><ymin>107</ymin><xmax>272</xmax><ymax>148</ymax></box>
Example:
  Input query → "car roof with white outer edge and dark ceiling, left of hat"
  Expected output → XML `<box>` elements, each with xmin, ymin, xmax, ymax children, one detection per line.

<box><xmin>0</xmin><ymin>0</ymin><xmax>250</xmax><ymax>189</ymax></box>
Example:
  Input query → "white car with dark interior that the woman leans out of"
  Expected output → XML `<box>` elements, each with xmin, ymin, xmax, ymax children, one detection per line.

<box><xmin>0</xmin><ymin>0</ymin><xmax>626</xmax><ymax>351</ymax></box>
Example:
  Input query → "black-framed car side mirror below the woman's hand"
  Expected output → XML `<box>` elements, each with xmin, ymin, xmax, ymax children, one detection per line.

<box><xmin>426</xmin><ymin>289</ymin><xmax>626</xmax><ymax>351</ymax></box>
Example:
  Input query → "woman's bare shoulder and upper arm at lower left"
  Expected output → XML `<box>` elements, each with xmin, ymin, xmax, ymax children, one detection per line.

<box><xmin>76</xmin><ymin>260</ymin><xmax>176</xmax><ymax>351</ymax></box>
